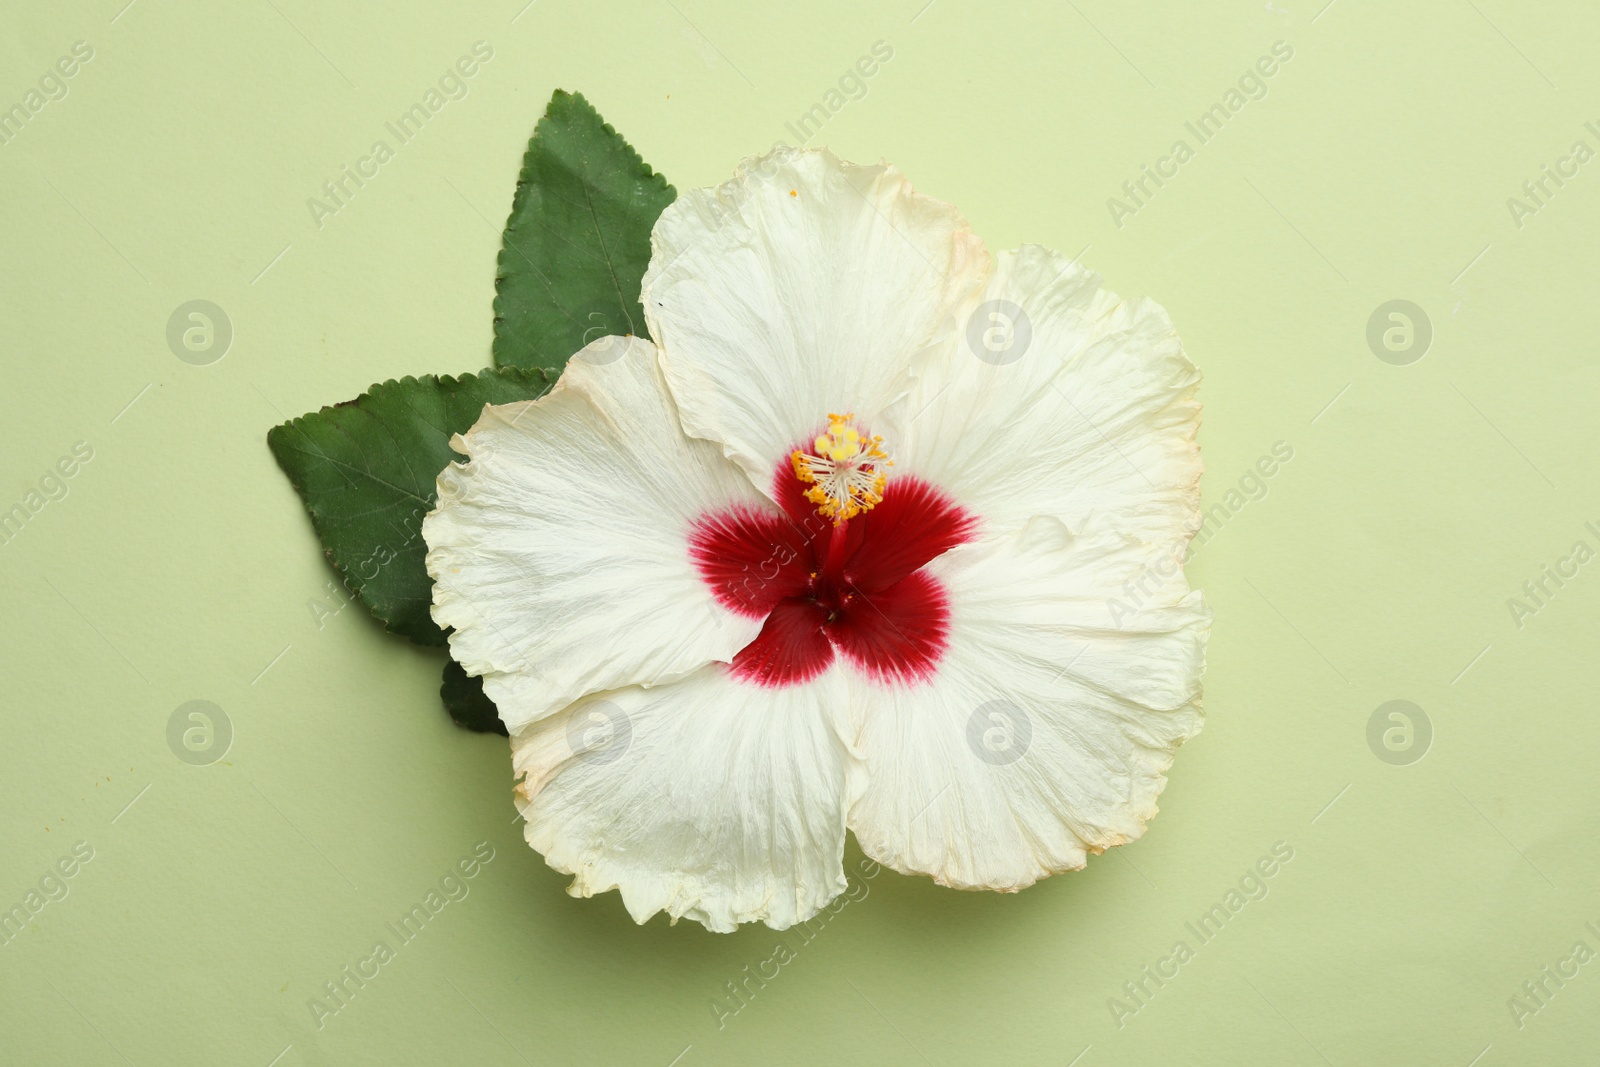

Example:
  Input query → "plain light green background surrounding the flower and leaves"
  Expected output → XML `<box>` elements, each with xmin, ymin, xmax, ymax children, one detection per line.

<box><xmin>0</xmin><ymin>0</ymin><xmax>1600</xmax><ymax>1067</ymax></box>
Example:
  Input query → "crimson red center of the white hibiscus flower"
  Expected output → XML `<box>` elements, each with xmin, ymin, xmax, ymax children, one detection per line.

<box><xmin>690</xmin><ymin>464</ymin><xmax>978</xmax><ymax>686</ymax></box>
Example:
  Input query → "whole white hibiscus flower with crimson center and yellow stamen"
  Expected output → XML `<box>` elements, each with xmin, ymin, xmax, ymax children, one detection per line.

<box><xmin>422</xmin><ymin>149</ymin><xmax>1210</xmax><ymax>931</ymax></box>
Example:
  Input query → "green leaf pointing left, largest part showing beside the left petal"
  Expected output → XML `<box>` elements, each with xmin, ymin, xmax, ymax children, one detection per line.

<box><xmin>267</xmin><ymin>368</ymin><xmax>554</xmax><ymax>645</ymax></box>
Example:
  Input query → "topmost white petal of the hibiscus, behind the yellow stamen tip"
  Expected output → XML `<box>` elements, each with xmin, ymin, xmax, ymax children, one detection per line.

<box><xmin>640</xmin><ymin>147</ymin><xmax>989</xmax><ymax>491</ymax></box>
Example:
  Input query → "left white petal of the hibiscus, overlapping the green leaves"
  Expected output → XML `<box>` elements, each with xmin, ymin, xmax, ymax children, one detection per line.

<box><xmin>422</xmin><ymin>338</ymin><xmax>765</xmax><ymax>731</ymax></box>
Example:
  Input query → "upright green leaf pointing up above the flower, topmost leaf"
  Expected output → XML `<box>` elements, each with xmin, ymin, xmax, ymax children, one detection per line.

<box><xmin>494</xmin><ymin>90</ymin><xmax>678</xmax><ymax>371</ymax></box>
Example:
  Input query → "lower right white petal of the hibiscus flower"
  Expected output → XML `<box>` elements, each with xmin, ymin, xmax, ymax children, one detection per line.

<box><xmin>850</xmin><ymin>518</ymin><xmax>1210</xmax><ymax>891</ymax></box>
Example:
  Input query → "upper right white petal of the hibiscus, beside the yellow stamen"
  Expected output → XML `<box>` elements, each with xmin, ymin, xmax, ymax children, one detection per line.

<box><xmin>883</xmin><ymin>246</ymin><xmax>1202</xmax><ymax>544</ymax></box>
